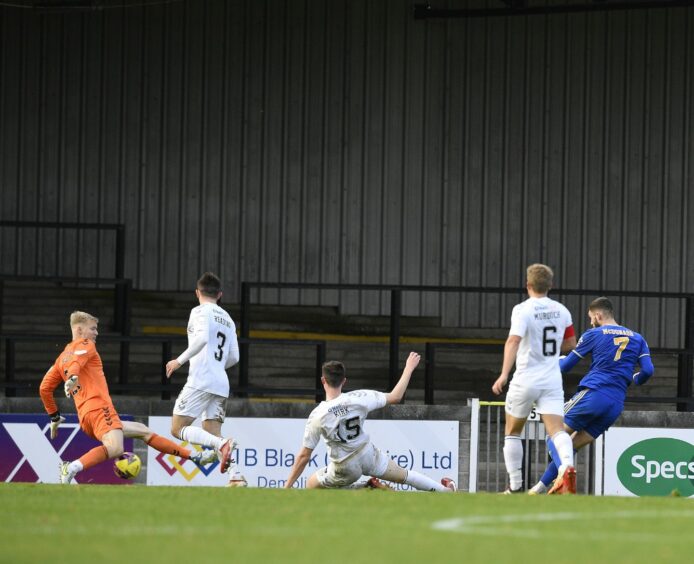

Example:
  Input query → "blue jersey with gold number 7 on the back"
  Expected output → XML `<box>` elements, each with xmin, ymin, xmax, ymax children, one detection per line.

<box><xmin>560</xmin><ymin>325</ymin><xmax>651</xmax><ymax>403</ymax></box>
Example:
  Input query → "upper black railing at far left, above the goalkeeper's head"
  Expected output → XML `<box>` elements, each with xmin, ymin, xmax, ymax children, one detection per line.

<box><xmin>0</xmin><ymin>221</ymin><xmax>132</xmax><ymax>335</ymax></box>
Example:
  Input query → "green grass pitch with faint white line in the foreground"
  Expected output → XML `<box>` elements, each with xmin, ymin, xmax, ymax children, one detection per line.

<box><xmin>0</xmin><ymin>484</ymin><xmax>694</xmax><ymax>564</ymax></box>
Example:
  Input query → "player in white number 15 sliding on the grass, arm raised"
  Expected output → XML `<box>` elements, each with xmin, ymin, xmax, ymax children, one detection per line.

<box><xmin>284</xmin><ymin>353</ymin><xmax>456</xmax><ymax>492</ymax></box>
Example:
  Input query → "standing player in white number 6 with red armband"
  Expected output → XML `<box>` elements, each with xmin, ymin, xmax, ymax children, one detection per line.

<box><xmin>492</xmin><ymin>264</ymin><xmax>576</xmax><ymax>493</ymax></box>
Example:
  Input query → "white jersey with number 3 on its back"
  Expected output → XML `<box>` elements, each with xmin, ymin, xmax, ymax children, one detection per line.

<box><xmin>177</xmin><ymin>303</ymin><xmax>239</xmax><ymax>397</ymax></box>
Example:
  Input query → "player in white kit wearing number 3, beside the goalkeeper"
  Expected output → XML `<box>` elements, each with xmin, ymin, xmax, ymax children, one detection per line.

<box><xmin>166</xmin><ymin>272</ymin><xmax>247</xmax><ymax>486</ymax></box>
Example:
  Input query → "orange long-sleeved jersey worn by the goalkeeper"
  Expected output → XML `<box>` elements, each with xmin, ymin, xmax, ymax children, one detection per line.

<box><xmin>40</xmin><ymin>339</ymin><xmax>112</xmax><ymax>420</ymax></box>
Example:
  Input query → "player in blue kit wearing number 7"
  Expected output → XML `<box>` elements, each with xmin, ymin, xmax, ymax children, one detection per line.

<box><xmin>528</xmin><ymin>298</ymin><xmax>654</xmax><ymax>494</ymax></box>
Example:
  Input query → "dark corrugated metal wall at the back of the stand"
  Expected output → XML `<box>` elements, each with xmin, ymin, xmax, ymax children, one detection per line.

<box><xmin>0</xmin><ymin>0</ymin><xmax>694</xmax><ymax>345</ymax></box>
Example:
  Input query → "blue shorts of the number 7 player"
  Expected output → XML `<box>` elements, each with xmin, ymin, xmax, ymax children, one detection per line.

<box><xmin>564</xmin><ymin>388</ymin><xmax>624</xmax><ymax>439</ymax></box>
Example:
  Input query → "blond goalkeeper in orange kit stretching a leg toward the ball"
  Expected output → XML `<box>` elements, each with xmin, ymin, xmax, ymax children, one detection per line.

<box><xmin>40</xmin><ymin>311</ymin><xmax>216</xmax><ymax>484</ymax></box>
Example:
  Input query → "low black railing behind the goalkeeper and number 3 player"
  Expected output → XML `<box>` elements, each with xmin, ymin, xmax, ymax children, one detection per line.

<box><xmin>0</xmin><ymin>335</ymin><xmax>325</xmax><ymax>402</ymax></box>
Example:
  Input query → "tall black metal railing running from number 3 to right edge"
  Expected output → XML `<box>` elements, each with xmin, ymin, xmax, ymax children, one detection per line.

<box><xmin>239</xmin><ymin>282</ymin><xmax>694</xmax><ymax>411</ymax></box>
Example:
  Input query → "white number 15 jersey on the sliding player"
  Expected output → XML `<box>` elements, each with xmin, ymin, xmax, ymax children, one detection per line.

<box><xmin>304</xmin><ymin>390</ymin><xmax>386</xmax><ymax>462</ymax></box>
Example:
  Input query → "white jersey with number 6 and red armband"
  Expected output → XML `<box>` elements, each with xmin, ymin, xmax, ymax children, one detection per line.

<box><xmin>509</xmin><ymin>297</ymin><xmax>572</xmax><ymax>389</ymax></box>
